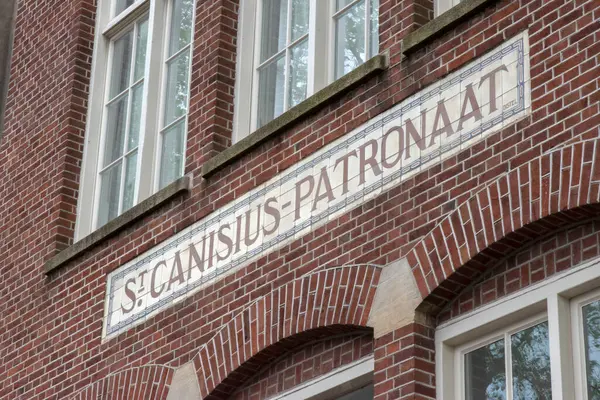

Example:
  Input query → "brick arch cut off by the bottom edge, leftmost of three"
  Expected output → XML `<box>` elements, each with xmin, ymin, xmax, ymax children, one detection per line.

<box><xmin>71</xmin><ymin>365</ymin><xmax>175</xmax><ymax>400</ymax></box>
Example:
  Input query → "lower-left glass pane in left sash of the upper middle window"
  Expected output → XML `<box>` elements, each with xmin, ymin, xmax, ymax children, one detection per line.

<box><xmin>258</xmin><ymin>56</ymin><xmax>285</xmax><ymax>127</ymax></box>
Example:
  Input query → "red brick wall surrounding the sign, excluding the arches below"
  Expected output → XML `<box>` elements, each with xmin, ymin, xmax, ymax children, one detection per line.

<box><xmin>0</xmin><ymin>0</ymin><xmax>600</xmax><ymax>399</ymax></box>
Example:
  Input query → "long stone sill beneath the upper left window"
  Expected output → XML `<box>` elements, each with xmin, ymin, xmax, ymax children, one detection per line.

<box><xmin>44</xmin><ymin>176</ymin><xmax>192</xmax><ymax>275</ymax></box>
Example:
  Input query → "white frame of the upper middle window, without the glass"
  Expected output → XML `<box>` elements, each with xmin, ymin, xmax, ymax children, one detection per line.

<box><xmin>232</xmin><ymin>0</ymin><xmax>380</xmax><ymax>143</ymax></box>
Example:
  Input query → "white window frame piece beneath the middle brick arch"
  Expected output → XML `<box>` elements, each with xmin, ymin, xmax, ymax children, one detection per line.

<box><xmin>269</xmin><ymin>355</ymin><xmax>375</xmax><ymax>400</ymax></box>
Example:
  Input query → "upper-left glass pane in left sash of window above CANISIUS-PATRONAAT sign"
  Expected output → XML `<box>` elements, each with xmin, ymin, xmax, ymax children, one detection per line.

<box><xmin>260</xmin><ymin>0</ymin><xmax>288</xmax><ymax>62</ymax></box>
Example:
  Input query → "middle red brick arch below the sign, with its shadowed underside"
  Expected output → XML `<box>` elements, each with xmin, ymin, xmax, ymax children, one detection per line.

<box><xmin>193</xmin><ymin>265</ymin><xmax>381</xmax><ymax>399</ymax></box>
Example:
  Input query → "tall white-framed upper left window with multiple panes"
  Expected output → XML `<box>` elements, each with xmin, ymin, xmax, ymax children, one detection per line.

<box><xmin>76</xmin><ymin>0</ymin><xmax>194</xmax><ymax>238</ymax></box>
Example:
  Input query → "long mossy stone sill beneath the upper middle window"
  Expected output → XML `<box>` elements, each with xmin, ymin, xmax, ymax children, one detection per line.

<box><xmin>202</xmin><ymin>54</ymin><xmax>389</xmax><ymax>178</ymax></box>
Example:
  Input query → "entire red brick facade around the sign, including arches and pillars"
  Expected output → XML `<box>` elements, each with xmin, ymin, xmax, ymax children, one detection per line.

<box><xmin>0</xmin><ymin>0</ymin><xmax>600</xmax><ymax>400</ymax></box>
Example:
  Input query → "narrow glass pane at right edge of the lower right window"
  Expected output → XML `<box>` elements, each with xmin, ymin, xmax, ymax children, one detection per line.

<box><xmin>583</xmin><ymin>301</ymin><xmax>600</xmax><ymax>400</ymax></box>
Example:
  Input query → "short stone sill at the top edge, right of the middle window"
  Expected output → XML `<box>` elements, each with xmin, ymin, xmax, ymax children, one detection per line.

<box><xmin>402</xmin><ymin>0</ymin><xmax>496</xmax><ymax>55</ymax></box>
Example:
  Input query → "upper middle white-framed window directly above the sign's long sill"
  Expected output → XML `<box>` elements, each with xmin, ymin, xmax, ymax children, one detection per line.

<box><xmin>234</xmin><ymin>0</ymin><xmax>379</xmax><ymax>139</ymax></box>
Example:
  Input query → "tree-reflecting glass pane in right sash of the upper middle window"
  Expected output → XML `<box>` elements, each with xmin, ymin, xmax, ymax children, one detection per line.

<box><xmin>335</xmin><ymin>0</ymin><xmax>366</xmax><ymax>78</ymax></box>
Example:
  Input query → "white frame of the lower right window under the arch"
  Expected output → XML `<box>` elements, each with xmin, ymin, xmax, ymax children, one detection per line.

<box><xmin>435</xmin><ymin>258</ymin><xmax>600</xmax><ymax>400</ymax></box>
